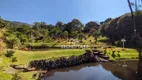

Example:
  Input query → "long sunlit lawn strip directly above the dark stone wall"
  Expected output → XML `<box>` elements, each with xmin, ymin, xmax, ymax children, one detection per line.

<box><xmin>15</xmin><ymin>49</ymin><xmax>85</xmax><ymax>64</ymax></box>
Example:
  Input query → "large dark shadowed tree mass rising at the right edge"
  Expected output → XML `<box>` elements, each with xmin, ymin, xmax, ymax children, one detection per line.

<box><xmin>100</xmin><ymin>13</ymin><xmax>142</xmax><ymax>46</ymax></box>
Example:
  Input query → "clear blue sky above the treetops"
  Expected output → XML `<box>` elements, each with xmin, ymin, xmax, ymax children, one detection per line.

<box><xmin>0</xmin><ymin>0</ymin><xmax>133</xmax><ymax>24</ymax></box>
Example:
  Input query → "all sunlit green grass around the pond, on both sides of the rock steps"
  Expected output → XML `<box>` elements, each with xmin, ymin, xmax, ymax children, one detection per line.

<box><xmin>0</xmin><ymin>48</ymin><xmax>138</xmax><ymax>80</ymax></box>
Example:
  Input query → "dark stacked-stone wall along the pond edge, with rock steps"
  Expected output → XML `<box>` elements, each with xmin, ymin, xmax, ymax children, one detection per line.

<box><xmin>30</xmin><ymin>50</ymin><xmax>109</xmax><ymax>70</ymax></box>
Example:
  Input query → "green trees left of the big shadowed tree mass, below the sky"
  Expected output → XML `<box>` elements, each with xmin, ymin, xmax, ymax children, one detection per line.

<box><xmin>0</xmin><ymin>18</ymin><xmax>100</xmax><ymax>49</ymax></box>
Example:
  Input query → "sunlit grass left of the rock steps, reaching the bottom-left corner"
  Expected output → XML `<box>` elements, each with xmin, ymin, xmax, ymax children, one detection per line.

<box><xmin>0</xmin><ymin>49</ymin><xmax>85</xmax><ymax>80</ymax></box>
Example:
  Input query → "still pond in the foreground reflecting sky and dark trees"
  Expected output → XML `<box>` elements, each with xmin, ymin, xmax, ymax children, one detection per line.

<box><xmin>41</xmin><ymin>60</ymin><xmax>140</xmax><ymax>80</ymax></box>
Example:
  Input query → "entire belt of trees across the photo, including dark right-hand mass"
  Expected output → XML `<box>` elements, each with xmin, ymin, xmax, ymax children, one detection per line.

<box><xmin>0</xmin><ymin>13</ymin><xmax>142</xmax><ymax>52</ymax></box>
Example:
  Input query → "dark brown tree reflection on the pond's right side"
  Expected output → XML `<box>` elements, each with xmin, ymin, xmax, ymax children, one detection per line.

<box><xmin>103</xmin><ymin>61</ymin><xmax>138</xmax><ymax>80</ymax></box>
